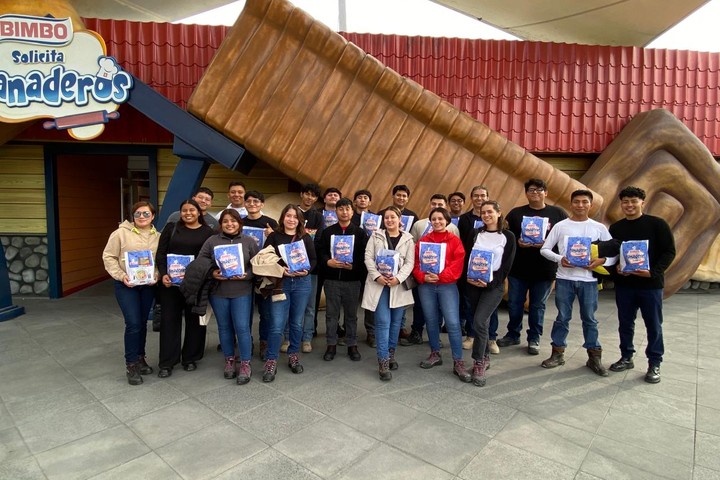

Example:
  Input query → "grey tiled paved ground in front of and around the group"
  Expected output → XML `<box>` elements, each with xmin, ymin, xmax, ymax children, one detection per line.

<box><xmin>0</xmin><ymin>284</ymin><xmax>720</xmax><ymax>480</ymax></box>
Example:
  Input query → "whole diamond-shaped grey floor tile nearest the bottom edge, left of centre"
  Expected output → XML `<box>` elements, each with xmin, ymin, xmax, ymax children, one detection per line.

<box><xmin>274</xmin><ymin>418</ymin><xmax>377</xmax><ymax>478</ymax></box>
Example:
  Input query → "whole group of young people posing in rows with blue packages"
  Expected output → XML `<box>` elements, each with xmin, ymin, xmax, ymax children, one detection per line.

<box><xmin>103</xmin><ymin>179</ymin><xmax>674</xmax><ymax>386</ymax></box>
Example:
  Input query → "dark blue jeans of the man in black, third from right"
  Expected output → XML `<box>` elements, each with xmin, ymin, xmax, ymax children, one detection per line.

<box><xmin>507</xmin><ymin>277</ymin><xmax>552</xmax><ymax>343</ymax></box>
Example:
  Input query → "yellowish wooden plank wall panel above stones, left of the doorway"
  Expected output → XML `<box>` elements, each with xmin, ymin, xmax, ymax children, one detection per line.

<box><xmin>0</xmin><ymin>145</ymin><xmax>47</xmax><ymax>234</ymax></box>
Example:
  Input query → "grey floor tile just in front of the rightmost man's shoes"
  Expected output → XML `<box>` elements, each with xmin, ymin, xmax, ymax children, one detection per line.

<box><xmin>612</xmin><ymin>389</ymin><xmax>696</xmax><ymax>429</ymax></box>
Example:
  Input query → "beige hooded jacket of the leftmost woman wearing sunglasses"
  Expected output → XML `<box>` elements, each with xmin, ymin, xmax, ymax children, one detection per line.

<box><xmin>103</xmin><ymin>220</ymin><xmax>160</xmax><ymax>282</ymax></box>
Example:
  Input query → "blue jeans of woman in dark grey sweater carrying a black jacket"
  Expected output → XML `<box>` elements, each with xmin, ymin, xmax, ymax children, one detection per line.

<box><xmin>210</xmin><ymin>294</ymin><xmax>252</xmax><ymax>360</ymax></box>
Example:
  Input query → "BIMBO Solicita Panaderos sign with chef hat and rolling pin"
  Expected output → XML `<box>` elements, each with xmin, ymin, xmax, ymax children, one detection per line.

<box><xmin>0</xmin><ymin>15</ymin><xmax>133</xmax><ymax>140</ymax></box>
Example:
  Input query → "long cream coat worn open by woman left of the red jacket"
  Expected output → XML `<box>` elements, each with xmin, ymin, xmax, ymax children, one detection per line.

<box><xmin>362</xmin><ymin>230</ymin><xmax>415</xmax><ymax>312</ymax></box>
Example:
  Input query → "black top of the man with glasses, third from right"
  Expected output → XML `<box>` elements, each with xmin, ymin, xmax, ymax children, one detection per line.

<box><xmin>505</xmin><ymin>205</ymin><xmax>567</xmax><ymax>281</ymax></box>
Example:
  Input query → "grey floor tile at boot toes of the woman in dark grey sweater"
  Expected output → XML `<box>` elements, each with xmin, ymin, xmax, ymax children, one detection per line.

<box><xmin>197</xmin><ymin>380</ymin><xmax>280</xmax><ymax>419</ymax></box>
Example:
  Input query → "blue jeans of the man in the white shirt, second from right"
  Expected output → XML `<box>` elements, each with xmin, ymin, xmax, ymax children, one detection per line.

<box><xmin>550</xmin><ymin>278</ymin><xmax>600</xmax><ymax>348</ymax></box>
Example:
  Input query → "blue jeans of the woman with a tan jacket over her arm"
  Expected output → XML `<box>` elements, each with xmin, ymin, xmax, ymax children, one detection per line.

<box><xmin>267</xmin><ymin>275</ymin><xmax>311</xmax><ymax>360</ymax></box>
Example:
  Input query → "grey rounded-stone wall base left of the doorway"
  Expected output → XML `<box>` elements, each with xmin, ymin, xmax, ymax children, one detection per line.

<box><xmin>0</xmin><ymin>235</ymin><xmax>49</xmax><ymax>297</ymax></box>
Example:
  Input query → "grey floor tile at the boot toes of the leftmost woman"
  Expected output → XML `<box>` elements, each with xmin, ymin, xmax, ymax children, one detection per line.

<box><xmin>101</xmin><ymin>376</ymin><xmax>188</xmax><ymax>422</ymax></box>
